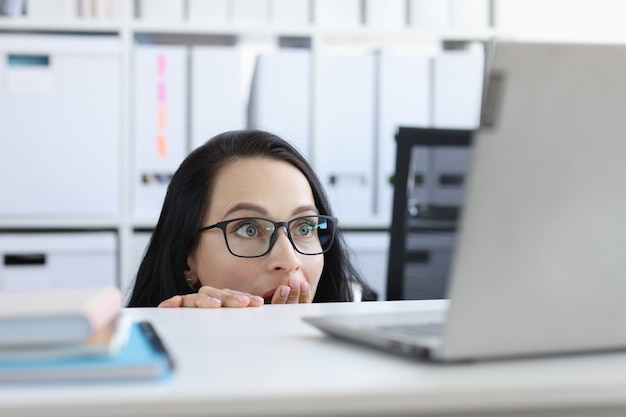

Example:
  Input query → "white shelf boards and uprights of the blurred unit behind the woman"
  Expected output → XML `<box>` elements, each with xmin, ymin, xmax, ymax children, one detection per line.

<box><xmin>0</xmin><ymin>1</ymin><xmax>493</xmax><ymax>296</ymax></box>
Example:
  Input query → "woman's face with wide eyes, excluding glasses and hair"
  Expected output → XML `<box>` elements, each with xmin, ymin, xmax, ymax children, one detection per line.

<box><xmin>188</xmin><ymin>157</ymin><xmax>324</xmax><ymax>300</ymax></box>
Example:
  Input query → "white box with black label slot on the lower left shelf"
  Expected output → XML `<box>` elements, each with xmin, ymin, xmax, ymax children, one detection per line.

<box><xmin>0</xmin><ymin>232</ymin><xmax>118</xmax><ymax>291</ymax></box>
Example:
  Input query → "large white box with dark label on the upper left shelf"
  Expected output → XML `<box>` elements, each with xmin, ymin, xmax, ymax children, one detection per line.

<box><xmin>0</xmin><ymin>34</ymin><xmax>121</xmax><ymax>216</ymax></box>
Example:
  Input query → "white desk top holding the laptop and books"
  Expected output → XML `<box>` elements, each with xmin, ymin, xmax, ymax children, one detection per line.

<box><xmin>0</xmin><ymin>301</ymin><xmax>626</xmax><ymax>417</ymax></box>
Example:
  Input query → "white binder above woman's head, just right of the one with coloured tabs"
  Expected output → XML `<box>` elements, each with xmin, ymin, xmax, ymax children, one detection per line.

<box><xmin>190</xmin><ymin>46</ymin><xmax>246</xmax><ymax>148</ymax></box>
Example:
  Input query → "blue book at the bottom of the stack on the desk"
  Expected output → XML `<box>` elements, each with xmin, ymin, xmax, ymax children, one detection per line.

<box><xmin>0</xmin><ymin>321</ymin><xmax>174</xmax><ymax>383</ymax></box>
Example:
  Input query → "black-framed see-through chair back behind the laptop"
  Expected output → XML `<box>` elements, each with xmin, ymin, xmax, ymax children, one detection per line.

<box><xmin>387</xmin><ymin>127</ymin><xmax>473</xmax><ymax>300</ymax></box>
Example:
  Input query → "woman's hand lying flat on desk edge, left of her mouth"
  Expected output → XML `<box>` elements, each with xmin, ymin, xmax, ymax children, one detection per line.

<box><xmin>159</xmin><ymin>286</ymin><xmax>264</xmax><ymax>308</ymax></box>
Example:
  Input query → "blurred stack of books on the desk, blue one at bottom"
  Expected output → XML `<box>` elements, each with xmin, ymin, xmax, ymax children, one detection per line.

<box><xmin>0</xmin><ymin>288</ymin><xmax>173</xmax><ymax>383</ymax></box>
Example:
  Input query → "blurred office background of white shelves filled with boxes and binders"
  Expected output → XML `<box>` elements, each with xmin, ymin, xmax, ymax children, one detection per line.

<box><xmin>0</xmin><ymin>0</ymin><xmax>626</xmax><ymax>299</ymax></box>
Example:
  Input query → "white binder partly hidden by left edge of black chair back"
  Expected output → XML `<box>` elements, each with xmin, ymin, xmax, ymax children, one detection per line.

<box><xmin>376</xmin><ymin>51</ymin><xmax>432</xmax><ymax>224</ymax></box>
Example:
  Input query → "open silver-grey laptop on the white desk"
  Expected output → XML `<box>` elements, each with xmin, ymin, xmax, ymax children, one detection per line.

<box><xmin>304</xmin><ymin>42</ymin><xmax>626</xmax><ymax>361</ymax></box>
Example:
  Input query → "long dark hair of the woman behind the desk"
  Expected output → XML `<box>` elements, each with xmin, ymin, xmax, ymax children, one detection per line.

<box><xmin>128</xmin><ymin>130</ymin><xmax>373</xmax><ymax>307</ymax></box>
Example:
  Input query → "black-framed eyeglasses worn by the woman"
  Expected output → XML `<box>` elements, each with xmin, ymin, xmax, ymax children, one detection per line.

<box><xmin>198</xmin><ymin>215</ymin><xmax>337</xmax><ymax>258</ymax></box>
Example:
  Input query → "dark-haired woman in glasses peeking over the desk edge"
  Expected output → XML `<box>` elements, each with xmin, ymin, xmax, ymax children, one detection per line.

<box><xmin>128</xmin><ymin>130</ymin><xmax>373</xmax><ymax>308</ymax></box>
